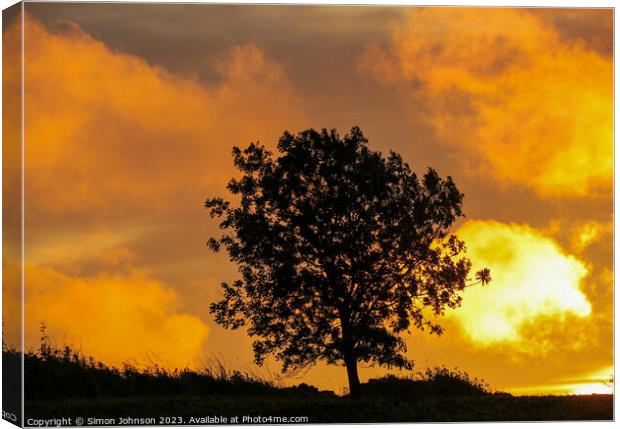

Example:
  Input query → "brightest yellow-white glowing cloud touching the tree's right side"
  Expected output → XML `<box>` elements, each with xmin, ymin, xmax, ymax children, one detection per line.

<box><xmin>451</xmin><ymin>221</ymin><xmax>591</xmax><ymax>346</ymax></box>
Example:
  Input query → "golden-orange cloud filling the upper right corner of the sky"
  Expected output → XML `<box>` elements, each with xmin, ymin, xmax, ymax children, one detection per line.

<box><xmin>360</xmin><ymin>8</ymin><xmax>613</xmax><ymax>197</ymax></box>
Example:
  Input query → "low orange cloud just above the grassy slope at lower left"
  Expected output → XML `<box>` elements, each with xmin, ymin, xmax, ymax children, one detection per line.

<box><xmin>25</xmin><ymin>266</ymin><xmax>208</xmax><ymax>368</ymax></box>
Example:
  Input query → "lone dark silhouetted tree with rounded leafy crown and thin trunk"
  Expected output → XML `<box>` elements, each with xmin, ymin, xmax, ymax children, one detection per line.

<box><xmin>205</xmin><ymin>127</ymin><xmax>490</xmax><ymax>396</ymax></box>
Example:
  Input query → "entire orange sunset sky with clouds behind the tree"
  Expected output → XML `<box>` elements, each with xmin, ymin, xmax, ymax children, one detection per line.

<box><xmin>3</xmin><ymin>3</ymin><xmax>613</xmax><ymax>394</ymax></box>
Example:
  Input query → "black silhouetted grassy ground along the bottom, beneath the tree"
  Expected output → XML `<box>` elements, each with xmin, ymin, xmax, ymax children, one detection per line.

<box><xmin>3</xmin><ymin>341</ymin><xmax>613</xmax><ymax>424</ymax></box>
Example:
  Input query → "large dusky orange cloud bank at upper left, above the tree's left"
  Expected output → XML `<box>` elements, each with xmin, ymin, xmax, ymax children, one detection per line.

<box><xmin>25</xmin><ymin>17</ymin><xmax>304</xmax><ymax>219</ymax></box>
